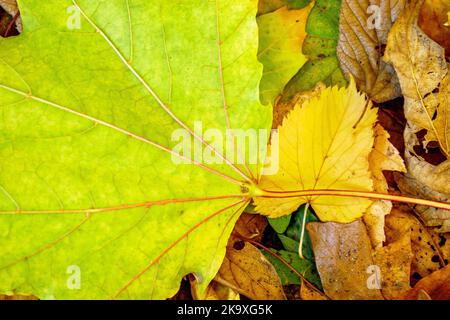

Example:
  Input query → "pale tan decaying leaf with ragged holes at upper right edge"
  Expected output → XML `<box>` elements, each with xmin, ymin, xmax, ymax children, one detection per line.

<box><xmin>385</xmin><ymin>0</ymin><xmax>450</xmax><ymax>155</ymax></box>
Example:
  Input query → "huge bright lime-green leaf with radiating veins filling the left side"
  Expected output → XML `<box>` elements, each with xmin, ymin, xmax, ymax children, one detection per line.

<box><xmin>0</xmin><ymin>0</ymin><xmax>271</xmax><ymax>299</ymax></box>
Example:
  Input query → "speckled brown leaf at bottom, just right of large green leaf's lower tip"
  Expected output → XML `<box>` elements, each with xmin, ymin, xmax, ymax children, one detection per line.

<box><xmin>215</xmin><ymin>237</ymin><xmax>286</xmax><ymax>300</ymax></box>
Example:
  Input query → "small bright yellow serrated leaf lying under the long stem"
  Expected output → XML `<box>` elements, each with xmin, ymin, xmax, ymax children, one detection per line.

<box><xmin>255</xmin><ymin>81</ymin><xmax>377</xmax><ymax>223</ymax></box>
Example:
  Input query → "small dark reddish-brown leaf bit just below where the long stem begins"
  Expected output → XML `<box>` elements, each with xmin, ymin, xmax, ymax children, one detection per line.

<box><xmin>233</xmin><ymin>212</ymin><xmax>267</xmax><ymax>242</ymax></box>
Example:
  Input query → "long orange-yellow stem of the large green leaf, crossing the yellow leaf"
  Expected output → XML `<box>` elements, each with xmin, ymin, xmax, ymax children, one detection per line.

<box><xmin>255</xmin><ymin>189</ymin><xmax>450</xmax><ymax>210</ymax></box>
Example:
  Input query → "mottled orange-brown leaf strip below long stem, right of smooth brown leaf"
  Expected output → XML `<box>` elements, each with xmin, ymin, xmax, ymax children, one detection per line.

<box><xmin>374</xmin><ymin>209</ymin><xmax>413</xmax><ymax>300</ymax></box>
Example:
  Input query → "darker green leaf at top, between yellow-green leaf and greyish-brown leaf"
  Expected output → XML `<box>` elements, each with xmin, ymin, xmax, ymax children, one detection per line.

<box><xmin>283</xmin><ymin>0</ymin><xmax>347</xmax><ymax>101</ymax></box>
